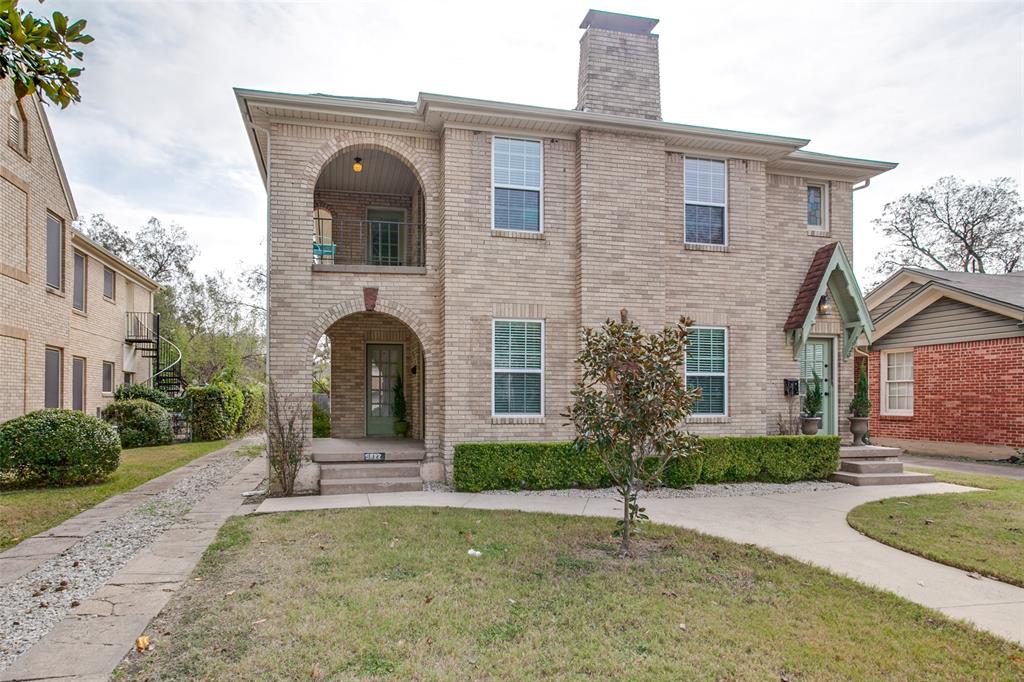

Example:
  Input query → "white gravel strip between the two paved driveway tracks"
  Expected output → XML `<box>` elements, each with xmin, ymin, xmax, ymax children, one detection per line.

<box><xmin>0</xmin><ymin>452</ymin><xmax>251</xmax><ymax>671</ymax></box>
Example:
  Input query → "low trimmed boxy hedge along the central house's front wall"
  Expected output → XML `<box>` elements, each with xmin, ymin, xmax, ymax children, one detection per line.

<box><xmin>453</xmin><ymin>435</ymin><xmax>840</xmax><ymax>493</ymax></box>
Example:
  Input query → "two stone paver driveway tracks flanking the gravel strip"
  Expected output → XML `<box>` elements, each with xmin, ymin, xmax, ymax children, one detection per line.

<box><xmin>0</xmin><ymin>437</ymin><xmax>266</xmax><ymax>682</ymax></box>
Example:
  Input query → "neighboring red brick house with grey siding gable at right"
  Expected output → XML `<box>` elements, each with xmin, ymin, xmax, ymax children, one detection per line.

<box><xmin>865</xmin><ymin>267</ymin><xmax>1024</xmax><ymax>459</ymax></box>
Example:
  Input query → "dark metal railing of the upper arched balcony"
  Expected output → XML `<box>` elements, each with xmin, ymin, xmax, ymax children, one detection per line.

<box><xmin>312</xmin><ymin>220</ymin><xmax>426</xmax><ymax>267</ymax></box>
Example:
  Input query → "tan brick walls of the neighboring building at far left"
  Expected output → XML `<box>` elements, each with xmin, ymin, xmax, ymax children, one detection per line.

<box><xmin>0</xmin><ymin>83</ymin><xmax>154</xmax><ymax>422</ymax></box>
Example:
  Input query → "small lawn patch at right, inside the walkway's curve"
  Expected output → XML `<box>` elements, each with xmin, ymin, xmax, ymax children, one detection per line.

<box><xmin>847</xmin><ymin>469</ymin><xmax>1024</xmax><ymax>587</ymax></box>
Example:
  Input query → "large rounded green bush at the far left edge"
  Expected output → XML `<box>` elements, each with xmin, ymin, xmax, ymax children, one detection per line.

<box><xmin>0</xmin><ymin>410</ymin><xmax>121</xmax><ymax>485</ymax></box>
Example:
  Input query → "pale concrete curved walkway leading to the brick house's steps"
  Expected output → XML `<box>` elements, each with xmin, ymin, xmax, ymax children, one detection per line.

<box><xmin>256</xmin><ymin>483</ymin><xmax>1024</xmax><ymax>644</ymax></box>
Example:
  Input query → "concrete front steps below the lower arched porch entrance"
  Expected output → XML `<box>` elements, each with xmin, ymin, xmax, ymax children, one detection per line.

<box><xmin>313</xmin><ymin>438</ymin><xmax>424</xmax><ymax>495</ymax></box>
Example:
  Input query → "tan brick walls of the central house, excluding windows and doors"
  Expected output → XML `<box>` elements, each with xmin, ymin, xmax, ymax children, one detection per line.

<box><xmin>239</xmin><ymin>10</ymin><xmax>891</xmax><ymax>489</ymax></box>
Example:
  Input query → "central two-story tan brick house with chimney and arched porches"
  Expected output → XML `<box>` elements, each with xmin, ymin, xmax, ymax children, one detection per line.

<box><xmin>236</xmin><ymin>11</ymin><xmax>894</xmax><ymax>492</ymax></box>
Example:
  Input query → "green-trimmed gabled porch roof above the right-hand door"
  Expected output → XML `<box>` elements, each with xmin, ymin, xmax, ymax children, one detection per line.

<box><xmin>784</xmin><ymin>242</ymin><xmax>874</xmax><ymax>358</ymax></box>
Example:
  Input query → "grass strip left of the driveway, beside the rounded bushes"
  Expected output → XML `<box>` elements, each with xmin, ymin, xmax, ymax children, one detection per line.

<box><xmin>0</xmin><ymin>440</ymin><xmax>228</xmax><ymax>551</ymax></box>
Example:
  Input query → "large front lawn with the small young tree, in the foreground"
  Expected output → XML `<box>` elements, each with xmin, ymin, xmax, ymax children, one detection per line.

<box><xmin>115</xmin><ymin>501</ymin><xmax>1024</xmax><ymax>682</ymax></box>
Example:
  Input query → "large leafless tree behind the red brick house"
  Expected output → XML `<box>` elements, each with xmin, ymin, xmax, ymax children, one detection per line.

<box><xmin>873</xmin><ymin>176</ymin><xmax>1024</xmax><ymax>275</ymax></box>
